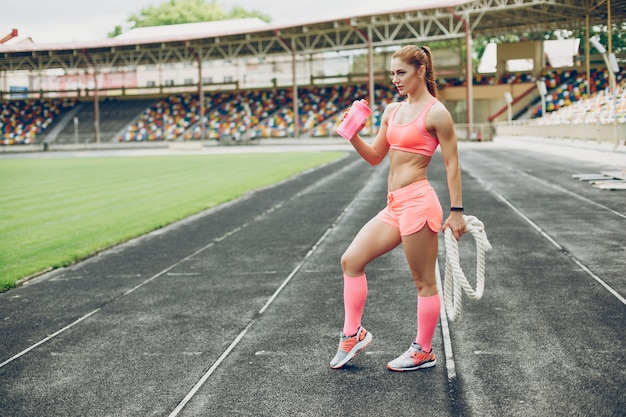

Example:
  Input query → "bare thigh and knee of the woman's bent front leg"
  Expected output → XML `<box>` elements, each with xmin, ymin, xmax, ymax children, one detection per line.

<box><xmin>341</xmin><ymin>214</ymin><xmax>402</xmax><ymax>276</ymax></box>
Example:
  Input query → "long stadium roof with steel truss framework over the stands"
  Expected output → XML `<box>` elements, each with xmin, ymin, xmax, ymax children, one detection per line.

<box><xmin>0</xmin><ymin>0</ymin><xmax>626</xmax><ymax>71</ymax></box>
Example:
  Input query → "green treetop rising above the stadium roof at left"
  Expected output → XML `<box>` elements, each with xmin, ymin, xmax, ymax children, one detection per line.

<box><xmin>108</xmin><ymin>0</ymin><xmax>271</xmax><ymax>37</ymax></box>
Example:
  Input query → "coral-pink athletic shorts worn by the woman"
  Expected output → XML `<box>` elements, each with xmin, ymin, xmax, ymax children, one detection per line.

<box><xmin>376</xmin><ymin>179</ymin><xmax>443</xmax><ymax>236</ymax></box>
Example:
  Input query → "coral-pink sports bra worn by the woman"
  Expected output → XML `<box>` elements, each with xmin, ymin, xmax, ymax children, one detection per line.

<box><xmin>387</xmin><ymin>97</ymin><xmax>439</xmax><ymax>156</ymax></box>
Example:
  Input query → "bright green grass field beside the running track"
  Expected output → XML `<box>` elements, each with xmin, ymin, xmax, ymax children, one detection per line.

<box><xmin>0</xmin><ymin>152</ymin><xmax>342</xmax><ymax>291</ymax></box>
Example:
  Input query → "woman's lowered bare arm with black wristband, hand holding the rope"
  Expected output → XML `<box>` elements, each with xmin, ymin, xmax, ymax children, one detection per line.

<box><xmin>427</xmin><ymin>103</ymin><xmax>465</xmax><ymax>240</ymax></box>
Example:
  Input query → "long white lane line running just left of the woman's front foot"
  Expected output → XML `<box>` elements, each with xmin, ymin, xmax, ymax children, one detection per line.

<box><xmin>169</xmin><ymin>162</ymin><xmax>374</xmax><ymax>417</ymax></box>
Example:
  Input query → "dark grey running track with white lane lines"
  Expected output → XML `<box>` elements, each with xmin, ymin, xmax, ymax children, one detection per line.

<box><xmin>0</xmin><ymin>140</ymin><xmax>626</xmax><ymax>417</ymax></box>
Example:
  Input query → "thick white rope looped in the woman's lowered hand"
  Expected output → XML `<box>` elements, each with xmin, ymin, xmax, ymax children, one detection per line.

<box><xmin>443</xmin><ymin>216</ymin><xmax>491</xmax><ymax>321</ymax></box>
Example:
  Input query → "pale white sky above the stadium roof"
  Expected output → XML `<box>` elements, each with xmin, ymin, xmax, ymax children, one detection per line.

<box><xmin>0</xmin><ymin>0</ymin><xmax>444</xmax><ymax>43</ymax></box>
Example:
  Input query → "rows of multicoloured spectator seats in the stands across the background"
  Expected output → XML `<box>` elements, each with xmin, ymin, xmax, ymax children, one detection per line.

<box><xmin>0</xmin><ymin>69</ymin><xmax>626</xmax><ymax>145</ymax></box>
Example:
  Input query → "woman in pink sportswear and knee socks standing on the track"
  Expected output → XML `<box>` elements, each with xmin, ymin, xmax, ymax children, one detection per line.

<box><xmin>330</xmin><ymin>45</ymin><xmax>465</xmax><ymax>371</ymax></box>
